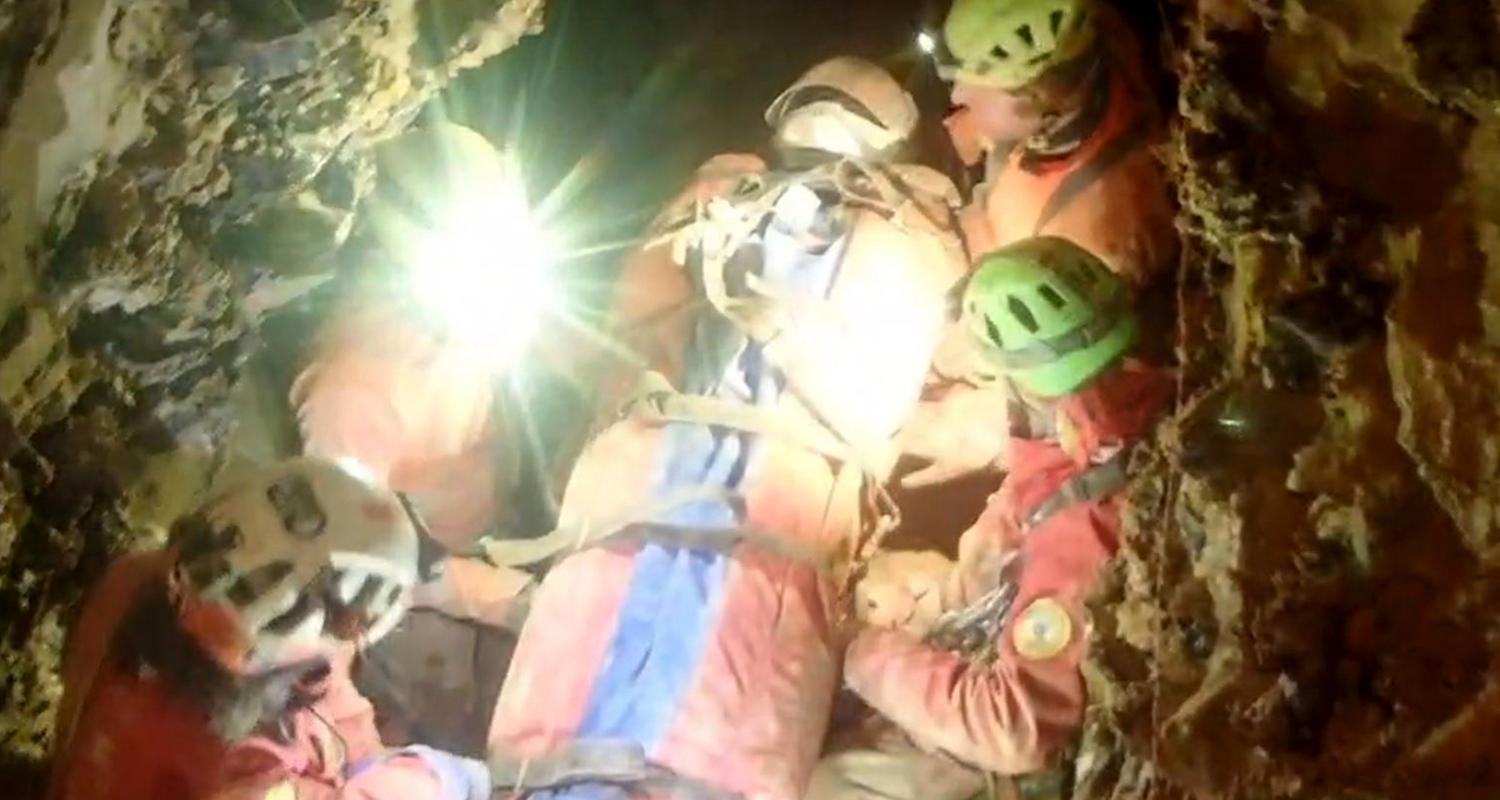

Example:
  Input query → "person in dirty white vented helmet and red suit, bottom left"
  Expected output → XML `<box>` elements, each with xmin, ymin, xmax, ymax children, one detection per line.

<box><xmin>50</xmin><ymin>459</ymin><xmax>489</xmax><ymax>800</ymax></box>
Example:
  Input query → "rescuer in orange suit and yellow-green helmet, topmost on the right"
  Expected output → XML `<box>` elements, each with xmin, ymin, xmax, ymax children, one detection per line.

<box><xmin>936</xmin><ymin>0</ymin><xmax>1176</xmax><ymax>282</ymax></box>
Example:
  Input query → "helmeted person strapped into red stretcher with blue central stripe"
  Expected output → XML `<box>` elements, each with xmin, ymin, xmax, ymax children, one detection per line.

<box><xmin>491</xmin><ymin>59</ymin><xmax>965</xmax><ymax>800</ymax></box>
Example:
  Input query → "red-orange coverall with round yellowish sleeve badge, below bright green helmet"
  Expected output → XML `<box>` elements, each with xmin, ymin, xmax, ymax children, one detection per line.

<box><xmin>845</xmin><ymin>362</ymin><xmax>1172</xmax><ymax>774</ymax></box>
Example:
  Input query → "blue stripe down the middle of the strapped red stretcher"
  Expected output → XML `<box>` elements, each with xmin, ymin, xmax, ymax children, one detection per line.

<box><xmin>536</xmin><ymin>195</ymin><xmax>845</xmax><ymax>800</ymax></box>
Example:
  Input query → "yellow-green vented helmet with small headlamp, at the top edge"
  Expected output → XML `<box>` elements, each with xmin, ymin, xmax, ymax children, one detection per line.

<box><xmin>944</xmin><ymin>0</ymin><xmax>1094</xmax><ymax>90</ymax></box>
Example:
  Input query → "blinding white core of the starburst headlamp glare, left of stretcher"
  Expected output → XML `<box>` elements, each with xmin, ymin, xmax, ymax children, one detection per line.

<box><xmin>408</xmin><ymin>171</ymin><xmax>558</xmax><ymax>366</ymax></box>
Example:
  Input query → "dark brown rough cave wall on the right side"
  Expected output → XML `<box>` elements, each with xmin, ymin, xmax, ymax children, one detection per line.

<box><xmin>1079</xmin><ymin>0</ymin><xmax>1500</xmax><ymax>800</ymax></box>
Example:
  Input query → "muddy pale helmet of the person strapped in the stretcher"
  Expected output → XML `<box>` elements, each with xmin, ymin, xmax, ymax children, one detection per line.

<box><xmin>765</xmin><ymin>56</ymin><xmax>918</xmax><ymax>159</ymax></box>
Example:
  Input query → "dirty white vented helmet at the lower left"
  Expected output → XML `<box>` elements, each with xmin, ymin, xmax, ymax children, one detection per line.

<box><xmin>171</xmin><ymin>458</ymin><xmax>422</xmax><ymax>672</ymax></box>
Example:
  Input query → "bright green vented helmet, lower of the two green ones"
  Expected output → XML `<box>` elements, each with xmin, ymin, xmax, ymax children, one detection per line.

<box><xmin>963</xmin><ymin>236</ymin><xmax>1136</xmax><ymax>398</ymax></box>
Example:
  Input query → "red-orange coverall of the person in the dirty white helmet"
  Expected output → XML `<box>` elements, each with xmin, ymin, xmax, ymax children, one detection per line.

<box><xmin>48</xmin><ymin>551</ymin><xmax>479</xmax><ymax>800</ymax></box>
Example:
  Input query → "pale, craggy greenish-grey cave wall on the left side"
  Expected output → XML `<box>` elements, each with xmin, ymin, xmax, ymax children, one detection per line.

<box><xmin>0</xmin><ymin>0</ymin><xmax>543</xmax><ymax>774</ymax></box>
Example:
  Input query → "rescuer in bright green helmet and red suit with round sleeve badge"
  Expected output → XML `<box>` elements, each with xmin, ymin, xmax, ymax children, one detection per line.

<box><xmin>845</xmin><ymin>237</ymin><xmax>1172</xmax><ymax>774</ymax></box>
